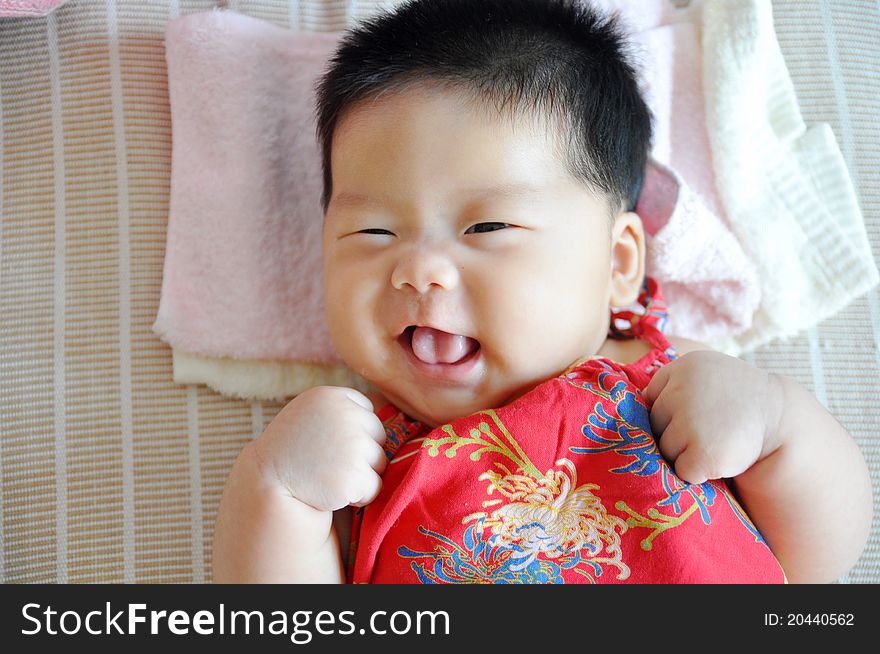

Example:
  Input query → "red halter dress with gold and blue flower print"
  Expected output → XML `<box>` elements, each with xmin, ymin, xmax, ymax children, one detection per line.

<box><xmin>348</xmin><ymin>278</ymin><xmax>785</xmax><ymax>584</ymax></box>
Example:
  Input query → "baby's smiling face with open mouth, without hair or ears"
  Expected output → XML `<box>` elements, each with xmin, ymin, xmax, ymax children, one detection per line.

<box><xmin>323</xmin><ymin>84</ymin><xmax>624</xmax><ymax>426</ymax></box>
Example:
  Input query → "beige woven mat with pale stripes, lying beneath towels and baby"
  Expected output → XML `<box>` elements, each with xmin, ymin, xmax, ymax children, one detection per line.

<box><xmin>0</xmin><ymin>0</ymin><xmax>880</xmax><ymax>583</ymax></box>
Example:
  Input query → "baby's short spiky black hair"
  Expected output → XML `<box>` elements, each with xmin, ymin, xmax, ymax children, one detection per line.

<box><xmin>316</xmin><ymin>0</ymin><xmax>651</xmax><ymax>220</ymax></box>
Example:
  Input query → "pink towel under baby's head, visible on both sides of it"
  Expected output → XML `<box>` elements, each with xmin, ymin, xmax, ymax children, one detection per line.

<box><xmin>153</xmin><ymin>1</ymin><xmax>759</xmax><ymax>376</ymax></box>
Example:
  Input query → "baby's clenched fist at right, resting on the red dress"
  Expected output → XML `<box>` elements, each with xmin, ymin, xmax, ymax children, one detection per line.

<box><xmin>643</xmin><ymin>350</ymin><xmax>782</xmax><ymax>484</ymax></box>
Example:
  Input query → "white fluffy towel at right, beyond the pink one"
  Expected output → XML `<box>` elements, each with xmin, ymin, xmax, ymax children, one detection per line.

<box><xmin>702</xmin><ymin>0</ymin><xmax>880</xmax><ymax>353</ymax></box>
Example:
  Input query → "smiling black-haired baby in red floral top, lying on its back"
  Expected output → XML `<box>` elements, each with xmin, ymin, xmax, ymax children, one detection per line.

<box><xmin>213</xmin><ymin>0</ymin><xmax>872</xmax><ymax>583</ymax></box>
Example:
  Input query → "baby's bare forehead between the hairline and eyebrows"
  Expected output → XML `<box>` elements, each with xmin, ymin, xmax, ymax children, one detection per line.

<box><xmin>330</xmin><ymin>87</ymin><xmax>605</xmax><ymax>220</ymax></box>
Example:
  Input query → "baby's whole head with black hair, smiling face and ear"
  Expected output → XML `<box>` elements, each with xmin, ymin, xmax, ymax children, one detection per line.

<box><xmin>317</xmin><ymin>0</ymin><xmax>651</xmax><ymax>426</ymax></box>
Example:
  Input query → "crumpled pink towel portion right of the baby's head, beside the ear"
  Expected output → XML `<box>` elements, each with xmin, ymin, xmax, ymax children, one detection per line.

<box><xmin>624</xmin><ymin>9</ymin><xmax>761</xmax><ymax>342</ymax></box>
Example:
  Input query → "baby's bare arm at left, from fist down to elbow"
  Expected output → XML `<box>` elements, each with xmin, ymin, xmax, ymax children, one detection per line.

<box><xmin>213</xmin><ymin>387</ymin><xmax>386</xmax><ymax>583</ymax></box>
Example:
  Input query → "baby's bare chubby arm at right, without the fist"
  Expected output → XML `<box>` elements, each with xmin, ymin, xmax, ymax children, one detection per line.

<box><xmin>734</xmin><ymin>375</ymin><xmax>873</xmax><ymax>583</ymax></box>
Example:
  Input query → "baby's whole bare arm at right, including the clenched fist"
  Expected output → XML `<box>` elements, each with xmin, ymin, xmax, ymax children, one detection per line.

<box><xmin>645</xmin><ymin>338</ymin><xmax>873</xmax><ymax>582</ymax></box>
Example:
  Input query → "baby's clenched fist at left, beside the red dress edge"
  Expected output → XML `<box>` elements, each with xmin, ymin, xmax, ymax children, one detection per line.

<box><xmin>248</xmin><ymin>386</ymin><xmax>387</xmax><ymax>511</ymax></box>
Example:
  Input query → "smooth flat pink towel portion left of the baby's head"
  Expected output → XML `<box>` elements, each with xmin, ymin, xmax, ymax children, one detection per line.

<box><xmin>153</xmin><ymin>11</ymin><xmax>338</xmax><ymax>363</ymax></box>
